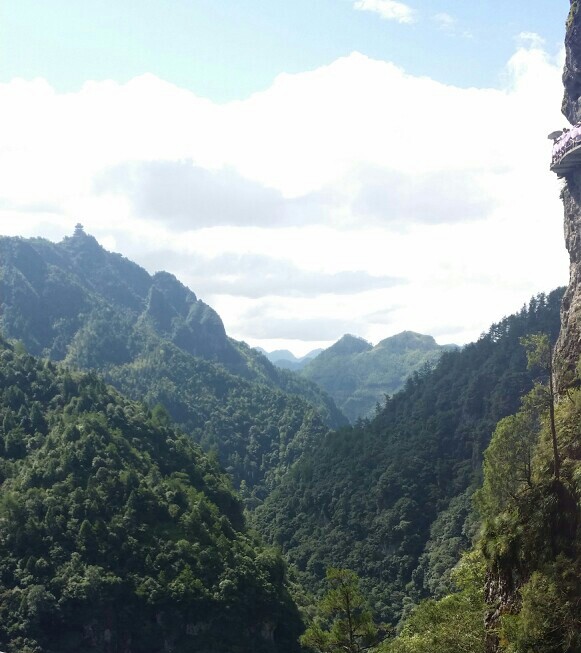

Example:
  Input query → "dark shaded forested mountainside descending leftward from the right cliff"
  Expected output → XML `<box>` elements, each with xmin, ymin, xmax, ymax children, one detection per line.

<box><xmin>255</xmin><ymin>290</ymin><xmax>562</xmax><ymax>623</ymax></box>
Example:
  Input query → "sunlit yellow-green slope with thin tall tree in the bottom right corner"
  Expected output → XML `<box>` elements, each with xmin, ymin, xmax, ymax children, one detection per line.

<box><xmin>382</xmin><ymin>334</ymin><xmax>581</xmax><ymax>653</ymax></box>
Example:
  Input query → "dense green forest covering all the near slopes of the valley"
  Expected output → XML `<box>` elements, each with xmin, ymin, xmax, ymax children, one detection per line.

<box><xmin>0</xmin><ymin>228</ymin><xmax>579</xmax><ymax>653</ymax></box>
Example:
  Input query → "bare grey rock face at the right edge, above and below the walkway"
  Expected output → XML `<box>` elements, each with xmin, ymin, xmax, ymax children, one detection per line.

<box><xmin>555</xmin><ymin>0</ymin><xmax>581</xmax><ymax>390</ymax></box>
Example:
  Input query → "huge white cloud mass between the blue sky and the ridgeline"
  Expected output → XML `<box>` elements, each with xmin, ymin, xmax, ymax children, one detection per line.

<box><xmin>0</xmin><ymin>38</ymin><xmax>567</xmax><ymax>350</ymax></box>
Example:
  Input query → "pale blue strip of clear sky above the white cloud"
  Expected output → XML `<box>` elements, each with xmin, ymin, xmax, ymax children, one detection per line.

<box><xmin>0</xmin><ymin>0</ymin><xmax>568</xmax><ymax>102</ymax></box>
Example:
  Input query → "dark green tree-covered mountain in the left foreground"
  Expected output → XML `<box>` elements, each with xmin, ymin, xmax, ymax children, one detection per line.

<box><xmin>0</xmin><ymin>340</ymin><xmax>301</xmax><ymax>653</ymax></box>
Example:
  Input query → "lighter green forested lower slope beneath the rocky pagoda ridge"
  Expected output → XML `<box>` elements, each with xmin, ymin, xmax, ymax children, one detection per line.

<box><xmin>105</xmin><ymin>343</ymin><xmax>328</xmax><ymax>507</ymax></box>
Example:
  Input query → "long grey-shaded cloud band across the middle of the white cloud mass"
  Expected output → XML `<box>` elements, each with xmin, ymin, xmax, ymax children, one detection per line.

<box><xmin>95</xmin><ymin>161</ymin><xmax>495</xmax><ymax>231</ymax></box>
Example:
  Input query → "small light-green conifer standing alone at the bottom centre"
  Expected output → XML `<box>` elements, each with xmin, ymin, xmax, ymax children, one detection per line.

<box><xmin>301</xmin><ymin>568</ymin><xmax>383</xmax><ymax>653</ymax></box>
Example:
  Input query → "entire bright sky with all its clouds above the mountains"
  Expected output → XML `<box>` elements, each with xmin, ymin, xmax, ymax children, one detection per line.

<box><xmin>0</xmin><ymin>0</ymin><xmax>569</xmax><ymax>355</ymax></box>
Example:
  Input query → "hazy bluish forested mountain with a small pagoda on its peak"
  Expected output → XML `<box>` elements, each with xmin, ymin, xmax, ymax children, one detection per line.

<box><xmin>0</xmin><ymin>225</ymin><xmax>346</xmax><ymax>502</ymax></box>
